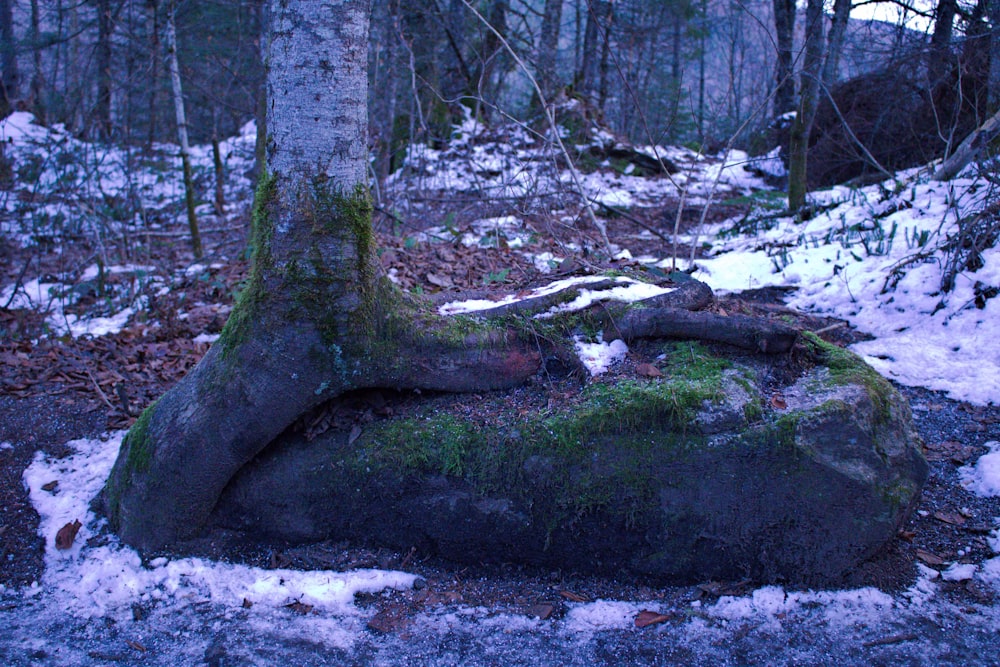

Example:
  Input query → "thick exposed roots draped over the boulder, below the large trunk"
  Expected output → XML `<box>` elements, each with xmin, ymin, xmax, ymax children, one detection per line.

<box><xmin>102</xmin><ymin>280</ymin><xmax>797</xmax><ymax>549</ymax></box>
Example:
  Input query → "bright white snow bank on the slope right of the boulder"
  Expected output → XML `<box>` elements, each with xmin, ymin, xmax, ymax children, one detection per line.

<box><xmin>688</xmin><ymin>169</ymin><xmax>1000</xmax><ymax>404</ymax></box>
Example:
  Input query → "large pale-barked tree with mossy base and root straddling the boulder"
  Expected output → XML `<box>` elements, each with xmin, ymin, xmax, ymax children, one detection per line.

<box><xmin>101</xmin><ymin>0</ymin><xmax>794</xmax><ymax>549</ymax></box>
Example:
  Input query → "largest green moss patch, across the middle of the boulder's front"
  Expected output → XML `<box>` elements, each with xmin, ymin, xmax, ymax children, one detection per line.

<box><xmin>352</xmin><ymin>348</ymin><xmax>728</xmax><ymax>529</ymax></box>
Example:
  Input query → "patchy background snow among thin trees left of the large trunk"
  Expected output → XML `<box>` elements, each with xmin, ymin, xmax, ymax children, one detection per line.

<box><xmin>0</xmin><ymin>111</ymin><xmax>256</xmax><ymax>337</ymax></box>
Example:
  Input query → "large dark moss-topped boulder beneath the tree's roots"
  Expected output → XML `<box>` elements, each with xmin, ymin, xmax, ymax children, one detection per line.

<box><xmin>207</xmin><ymin>337</ymin><xmax>927</xmax><ymax>584</ymax></box>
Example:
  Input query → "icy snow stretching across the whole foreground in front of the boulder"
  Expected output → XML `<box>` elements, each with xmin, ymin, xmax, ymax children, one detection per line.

<box><xmin>0</xmin><ymin>432</ymin><xmax>1000</xmax><ymax>665</ymax></box>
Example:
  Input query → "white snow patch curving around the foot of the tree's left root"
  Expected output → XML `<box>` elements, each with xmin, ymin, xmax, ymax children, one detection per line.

<box><xmin>24</xmin><ymin>431</ymin><xmax>416</xmax><ymax>622</ymax></box>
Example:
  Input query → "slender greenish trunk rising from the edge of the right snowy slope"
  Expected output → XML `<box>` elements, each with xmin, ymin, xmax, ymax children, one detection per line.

<box><xmin>788</xmin><ymin>0</ymin><xmax>823</xmax><ymax>211</ymax></box>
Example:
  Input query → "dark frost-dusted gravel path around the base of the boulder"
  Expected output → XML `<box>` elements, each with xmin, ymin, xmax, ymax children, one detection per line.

<box><xmin>0</xmin><ymin>370</ymin><xmax>1000</xmax><ymax>665</ymax></box>
